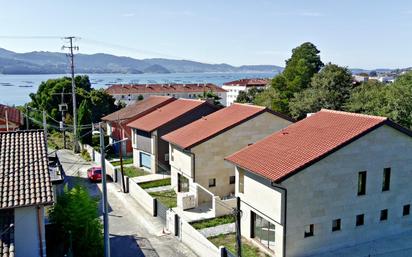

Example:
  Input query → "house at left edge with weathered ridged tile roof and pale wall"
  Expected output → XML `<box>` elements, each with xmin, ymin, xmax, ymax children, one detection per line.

<box><xmin>0</xmin><ymin>131</ymin><xmax>53</xmax><ymax>257</ymax></box>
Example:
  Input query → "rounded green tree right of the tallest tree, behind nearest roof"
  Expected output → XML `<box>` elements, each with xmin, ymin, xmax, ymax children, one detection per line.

<box><xmin>289</xmin><ymin>63</ymin><xmax>353</xmax><ymax>119</ymax></box>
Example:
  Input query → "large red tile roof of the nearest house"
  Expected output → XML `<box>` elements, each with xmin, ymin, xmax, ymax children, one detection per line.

<box><xmin>226</xmin><ymin>110</ymin><xmax>392</xmax><ymax>182</ymax></box>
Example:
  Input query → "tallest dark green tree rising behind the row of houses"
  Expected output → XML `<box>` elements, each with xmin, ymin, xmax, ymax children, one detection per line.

<box><xmin>257</xmin><ymin>42</ymin><xmax>323</xmax><ymax>114</ymax></box>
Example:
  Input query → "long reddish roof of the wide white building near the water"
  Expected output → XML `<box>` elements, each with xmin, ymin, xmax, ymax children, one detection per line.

<box><xmin>106</xmin><ymin>83</ymin><xmax>226</xmax><ymax>95</ymax></box>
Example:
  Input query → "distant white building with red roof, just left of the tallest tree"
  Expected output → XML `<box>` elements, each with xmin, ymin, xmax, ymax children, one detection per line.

<box><xmin>222</xmin><ymin>78</ymin><xmax>269</xmax><ymax>106</ymax></box>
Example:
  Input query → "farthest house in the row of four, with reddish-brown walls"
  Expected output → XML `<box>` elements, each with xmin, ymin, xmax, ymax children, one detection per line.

<box><xmin>102</xmin><ymin>96</ymin><xmax>176</xmax><ymax>155</ymax></box>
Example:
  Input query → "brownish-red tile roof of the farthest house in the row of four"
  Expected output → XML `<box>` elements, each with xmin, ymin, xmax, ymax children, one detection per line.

<box><xmin>102</xmin><ymin>96</ymin><xmax>176</xmax><ymax>121</ymax></box>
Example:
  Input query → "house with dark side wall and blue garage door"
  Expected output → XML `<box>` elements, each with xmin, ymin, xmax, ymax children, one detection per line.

<box><xmin>127</xmin><ymin>98</ymin><xmax>220</xmax><ymax>173</ymax></box>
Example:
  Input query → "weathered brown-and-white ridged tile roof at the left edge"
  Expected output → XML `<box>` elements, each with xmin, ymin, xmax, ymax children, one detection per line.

<box><xmin>0</xmin><ymin>130</ymin><xmax>53</xmax><ymax>209</ymax></box>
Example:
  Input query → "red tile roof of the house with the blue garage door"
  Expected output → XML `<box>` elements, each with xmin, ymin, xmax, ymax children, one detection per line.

<box><xmin>127</xmin><ymin>99</ymin><xmax>212</xmax><ymax>132</ymax></box>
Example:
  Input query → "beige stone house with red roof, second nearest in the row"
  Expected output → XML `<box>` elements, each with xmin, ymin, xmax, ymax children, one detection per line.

<box><xmin>162</xmin><ymin>104</ymin><xmax>292</xmax><ymax>215</ymax></box>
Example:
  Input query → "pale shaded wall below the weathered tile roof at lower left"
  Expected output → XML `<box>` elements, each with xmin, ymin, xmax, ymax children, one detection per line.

<box><xmin>14</xmin><ymin>206</ymin><xmax>46</xmax><ymax>257</ymax></box>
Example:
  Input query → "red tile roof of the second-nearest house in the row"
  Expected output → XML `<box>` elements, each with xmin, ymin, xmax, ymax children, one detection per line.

<box><xmin>162</xmin><ymin>103</ymin><xmax>283</xmax><ymax>149</ymax></box>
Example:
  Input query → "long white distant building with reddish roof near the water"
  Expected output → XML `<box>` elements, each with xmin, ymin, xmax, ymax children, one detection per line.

<box><xmin>106</xmin><ymin>83</ymin><xmax>226</xmax><ymax>106</ymax></box>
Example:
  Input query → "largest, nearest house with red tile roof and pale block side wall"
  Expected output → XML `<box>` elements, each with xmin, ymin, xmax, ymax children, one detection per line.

<box><xmin>226</xmin><ymin>110</ymin><xmax>412</xmax><ymax>256</ymax></box>
